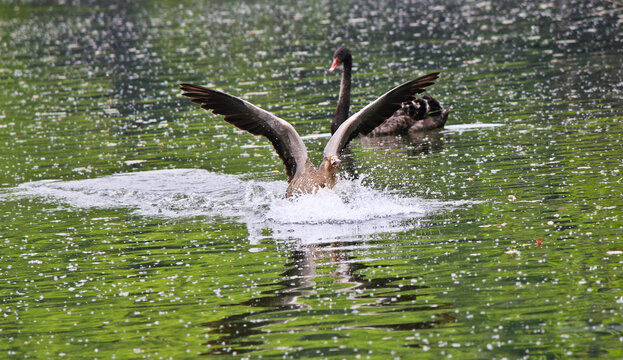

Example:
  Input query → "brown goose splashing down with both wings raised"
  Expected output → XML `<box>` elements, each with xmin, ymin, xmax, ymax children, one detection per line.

<box><xmin>180</xmin><ymin>73</ymin><xmax>439</xmax><ymax>197</ymax></box>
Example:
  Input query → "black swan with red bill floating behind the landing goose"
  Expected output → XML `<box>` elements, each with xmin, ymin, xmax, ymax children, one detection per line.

<box><xmin>329</xmin><ymin>47</ymin><xmax>451</xmax><ymax>136</ymax></box>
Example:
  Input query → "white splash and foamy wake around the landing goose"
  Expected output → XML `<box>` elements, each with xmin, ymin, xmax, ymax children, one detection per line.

<box><xmin>11</xmin><ymin>169</ymin><xmax>451</xmax><ymax>243</ymax></box>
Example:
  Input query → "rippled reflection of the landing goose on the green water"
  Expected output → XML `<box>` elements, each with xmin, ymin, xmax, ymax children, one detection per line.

<box><xmin>202</xmin><ymin>242</ymin><xmax>455</xmax><ymax>355</ymax></box>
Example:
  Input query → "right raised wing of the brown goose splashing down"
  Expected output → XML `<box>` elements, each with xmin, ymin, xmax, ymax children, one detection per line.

<box><xmin>324</xmin><ymin>72</ymin><xmax>439</xmax><ymax>157</ymax></box>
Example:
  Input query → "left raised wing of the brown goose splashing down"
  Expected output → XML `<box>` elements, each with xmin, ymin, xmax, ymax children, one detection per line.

<box><xmin>180</xmin><ymin>84</ymin><xmax>307</xmax><ymax>181</ymax></box>
